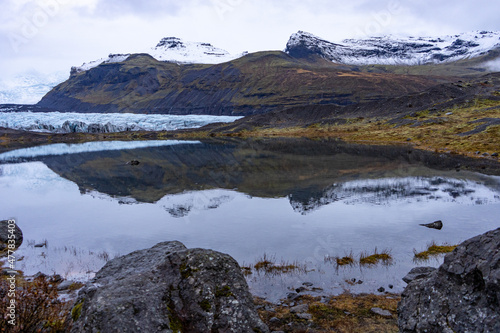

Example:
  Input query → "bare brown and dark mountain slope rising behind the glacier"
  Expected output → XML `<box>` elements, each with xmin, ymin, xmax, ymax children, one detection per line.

<box><xmin>38</xmin><ymin>51</ymin><xmax>436</xmax><ymax>115</ymax></box>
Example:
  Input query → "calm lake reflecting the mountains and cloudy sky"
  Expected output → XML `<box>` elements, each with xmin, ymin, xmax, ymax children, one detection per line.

<box><xmin>0</xmin><ymin>139</ymin><xmax>500</xmax><ymax>301</ymax></box>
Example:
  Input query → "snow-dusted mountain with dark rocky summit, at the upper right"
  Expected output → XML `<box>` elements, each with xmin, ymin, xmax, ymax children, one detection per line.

<box><xmin>285</xmin><ymin>31</ymin><xmax>500</xmax><ymax>65</ymax></box>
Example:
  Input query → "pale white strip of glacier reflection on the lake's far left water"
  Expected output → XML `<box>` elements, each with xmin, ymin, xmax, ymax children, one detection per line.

<box><xmin>0</xmin><ymin>140</ymin><xmax>201</xmax><ymax>162</ymax></box>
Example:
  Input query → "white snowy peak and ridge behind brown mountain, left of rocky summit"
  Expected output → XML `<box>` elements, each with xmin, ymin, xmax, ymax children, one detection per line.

<box><xmin>71</xmin><ymin>37</ymin><xmax>247</xmax><ymax>74</ymax></box>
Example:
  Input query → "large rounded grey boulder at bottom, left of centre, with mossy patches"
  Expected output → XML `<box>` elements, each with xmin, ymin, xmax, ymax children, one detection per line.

<box><xmin>71</xmin><ymin>242</ymin><xmax>269</xmax><ymax>333</ymax></box>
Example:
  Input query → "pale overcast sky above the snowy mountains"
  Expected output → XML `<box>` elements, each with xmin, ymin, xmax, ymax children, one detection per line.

<box><xmin>0</xmin><ymin>0</ymin><xmax>500</xmax><ymax>80</ymax></box>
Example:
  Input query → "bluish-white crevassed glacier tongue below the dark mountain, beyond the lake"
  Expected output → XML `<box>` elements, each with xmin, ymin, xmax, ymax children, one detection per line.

<box><xmin>0</xmin><ymin>111</ymin><xmax>242</xmax><ymax>133</ymax></box>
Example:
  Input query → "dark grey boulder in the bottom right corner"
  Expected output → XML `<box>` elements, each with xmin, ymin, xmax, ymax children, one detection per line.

<box><xmin>398</xmin><ymin>229</ymin><xmax>500</xmax><ymax>333</ymax></box>
